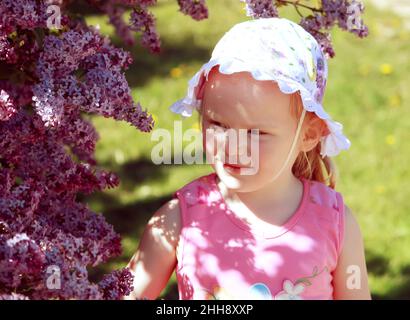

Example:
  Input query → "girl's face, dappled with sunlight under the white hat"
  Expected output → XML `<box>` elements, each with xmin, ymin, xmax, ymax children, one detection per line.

<box><xmin>199</xmin><ymin>68</ymin><xmax>302</xmax><ymax>192</ymax></box>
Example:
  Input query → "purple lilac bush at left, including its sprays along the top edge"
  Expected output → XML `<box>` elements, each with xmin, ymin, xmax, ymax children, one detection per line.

<box><xmin>0</xmin><ymin>0</ymin><xmax>367</xmax><ymax>300</ymax></box>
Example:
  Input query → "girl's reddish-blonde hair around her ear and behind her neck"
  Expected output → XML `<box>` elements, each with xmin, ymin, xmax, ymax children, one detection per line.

<box><xmin>290</xmin><ymin>92</ymin><xmax>338</xmax><ymax>189</ymax></box>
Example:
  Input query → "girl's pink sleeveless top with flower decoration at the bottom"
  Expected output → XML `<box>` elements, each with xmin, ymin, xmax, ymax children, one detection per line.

<box><xmin>175</xmin><ymin>173</ymin><xmax>344</xmax><ymax>300</ymax></box>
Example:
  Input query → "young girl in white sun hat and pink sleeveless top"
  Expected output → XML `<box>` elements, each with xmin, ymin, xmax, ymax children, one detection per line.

<box><xmin>125</xmin><ymin>18</ymin><xmax>370</xmax><ymax>300</ymax></box>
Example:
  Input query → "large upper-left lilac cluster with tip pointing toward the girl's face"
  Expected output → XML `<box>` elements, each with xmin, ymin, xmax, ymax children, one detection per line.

<box><xmin>33</xmin><ymin>29</ymin><xmax>153</xmax><ymax>132</ymax></box>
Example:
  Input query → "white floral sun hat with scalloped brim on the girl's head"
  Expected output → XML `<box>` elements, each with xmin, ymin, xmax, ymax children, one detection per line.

<box><xmin>170</xmin><ymin>18</ymin><xmax>351</xmax><ymax>157</ymax></box>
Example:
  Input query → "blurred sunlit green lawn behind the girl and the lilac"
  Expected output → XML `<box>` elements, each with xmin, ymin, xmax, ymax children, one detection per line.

<box><xmin>81</xmin><ymin>0</ymin><xmax>410</xmax><ymax>299</ymax></box>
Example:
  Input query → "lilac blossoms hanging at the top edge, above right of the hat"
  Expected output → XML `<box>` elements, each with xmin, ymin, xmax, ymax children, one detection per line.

<box><xmin>240</xmin><ymin>0</ymin><xmax>368</xmax><ymax>58</ymax></box>
